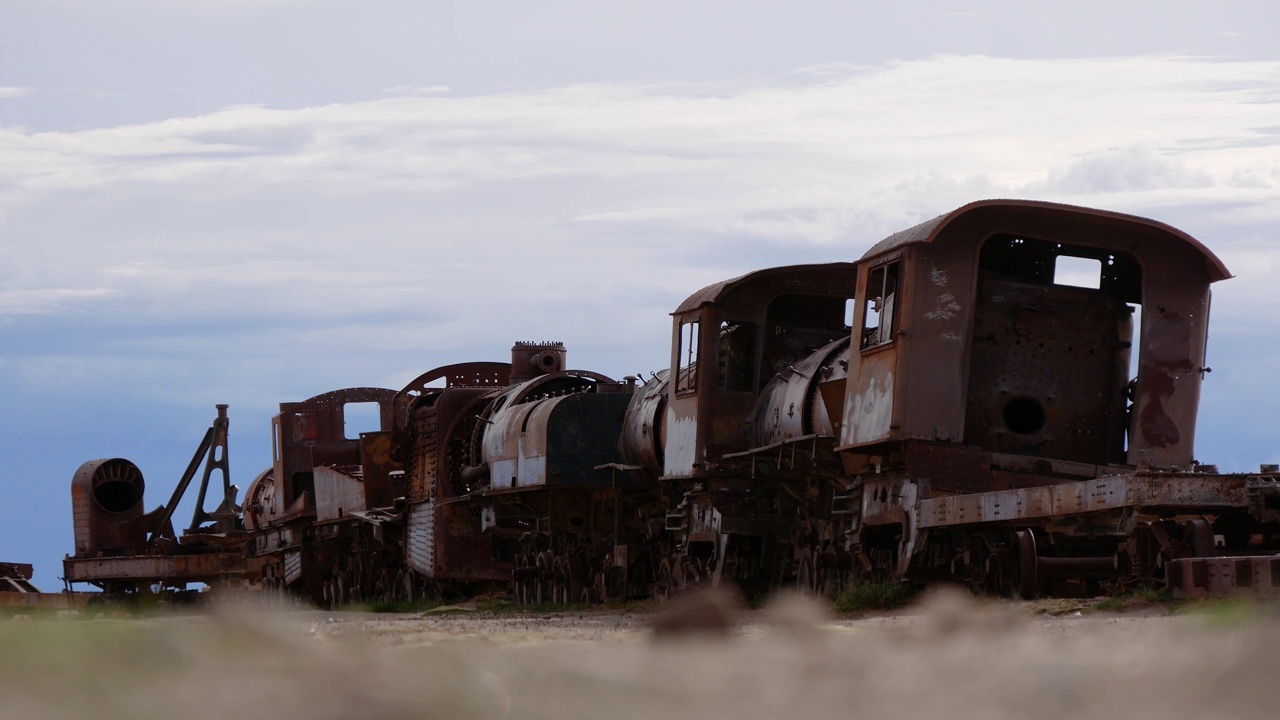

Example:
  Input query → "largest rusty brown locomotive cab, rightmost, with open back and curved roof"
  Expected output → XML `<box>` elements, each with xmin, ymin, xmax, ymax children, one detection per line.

<box><xmin>840</xmin><ymin>201</ymin><xmax>1229</xmax><ymax>474</ymax></box>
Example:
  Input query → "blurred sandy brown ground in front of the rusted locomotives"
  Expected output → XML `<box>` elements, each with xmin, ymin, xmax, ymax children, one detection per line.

<box><xmin>0</xmin><ymin>593</ymin><xmax>1280</xmax><ymax>720</ymax></box>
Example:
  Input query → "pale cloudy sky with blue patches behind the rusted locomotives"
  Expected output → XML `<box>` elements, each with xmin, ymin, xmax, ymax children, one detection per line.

<box><xmin>0</xmin><ymin>0</ymin><xmax>1280</xmax><ymax>591</ymax></box>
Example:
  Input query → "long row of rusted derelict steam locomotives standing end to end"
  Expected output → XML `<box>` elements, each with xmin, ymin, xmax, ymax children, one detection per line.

<box><xmin>64</xmin><ymin>200</ymin><xmax>1280</xmax><ymax>603</ymax></box>
